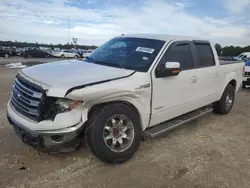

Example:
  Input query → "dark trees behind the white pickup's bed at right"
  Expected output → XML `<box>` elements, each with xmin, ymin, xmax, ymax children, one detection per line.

<box><xmin>214</xmin><ymin>44</ymin><xmax>250</xmax><ymax>56</ymax></box>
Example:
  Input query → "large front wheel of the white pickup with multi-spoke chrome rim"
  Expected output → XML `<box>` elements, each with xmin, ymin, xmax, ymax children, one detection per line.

<box><xmin>85</xmin><ymin>103</ymin><xmax>142</xmax><ymax>164</ymax></box>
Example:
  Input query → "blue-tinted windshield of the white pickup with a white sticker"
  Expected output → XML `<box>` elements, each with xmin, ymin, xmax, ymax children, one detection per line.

<box><xmin>84</xmin><ymin>37</ymin><xmax>165</xmax><ymax>72</ymax></box>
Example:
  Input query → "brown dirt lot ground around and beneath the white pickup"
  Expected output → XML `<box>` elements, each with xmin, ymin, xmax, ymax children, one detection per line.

<box><xmin>0</xmin><ymin>62</ymin><xmax>250</xmax><ymax>188</ymax></box>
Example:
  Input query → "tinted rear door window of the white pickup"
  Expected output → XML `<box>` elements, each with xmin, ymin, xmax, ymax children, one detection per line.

<box><xmin>195</xmin><ymin>43</ymin><xmax>215</xmax><ymax>67</ymax></box>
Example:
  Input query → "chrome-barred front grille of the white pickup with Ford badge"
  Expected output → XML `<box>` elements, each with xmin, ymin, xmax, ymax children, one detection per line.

<box><xmin>11</xmin><ymin>75</ymin><xmax>44</xmax><ymax>121</ymax></box>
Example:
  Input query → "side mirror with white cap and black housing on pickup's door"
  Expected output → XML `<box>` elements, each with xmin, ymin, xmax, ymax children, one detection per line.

<box><xmin>155</xmin><ymin>62</ymin><xmax>181</xmax><ymax>78</ymax></box>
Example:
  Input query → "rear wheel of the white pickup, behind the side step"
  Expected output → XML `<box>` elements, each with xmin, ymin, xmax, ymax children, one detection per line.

<box><xmin>214</xmin><ymin>84</ymin><xmax>235</xmax><ymax>114</ymax></box>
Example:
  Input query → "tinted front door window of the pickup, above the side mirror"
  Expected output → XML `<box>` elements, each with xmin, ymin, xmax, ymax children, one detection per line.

<box><xmin>160</xmin><ymin>43</ymin><xmax>193</xmax><ymax>70</ymax></box>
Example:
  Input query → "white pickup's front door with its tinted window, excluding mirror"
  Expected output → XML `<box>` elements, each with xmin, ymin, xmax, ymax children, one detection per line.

<box><xmin>150</xmin><ymin>41</ymin><xmax>199</xmax><ymax>126</ymax></box>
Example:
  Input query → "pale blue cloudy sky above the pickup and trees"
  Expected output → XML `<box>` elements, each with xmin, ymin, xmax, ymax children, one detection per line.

<box><xmin>0</xmin><ymin>0</ymin><xmax>250</xmax><ymax>46</ymax></box>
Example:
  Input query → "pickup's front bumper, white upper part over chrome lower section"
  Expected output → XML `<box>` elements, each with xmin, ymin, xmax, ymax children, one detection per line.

<box><xmin>7</xmin><ymin>100</ymin><xmax>84</xmax><ymax>151</ymax></box>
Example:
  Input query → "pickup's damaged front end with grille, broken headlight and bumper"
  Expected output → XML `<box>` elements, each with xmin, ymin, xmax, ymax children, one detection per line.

<box><xmin>7</xmin><ymin>72</ymin><xmax>87</xmax><ymax>151</ymax></box>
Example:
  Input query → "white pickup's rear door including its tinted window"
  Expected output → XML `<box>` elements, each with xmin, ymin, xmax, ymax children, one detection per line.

<box><xmin>191</xmin><ymin>41</ymin><xmax>223</xmax><ymax>105</ymax></box>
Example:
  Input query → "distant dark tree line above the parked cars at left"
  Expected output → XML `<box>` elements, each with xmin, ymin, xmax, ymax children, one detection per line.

<box><xmin>0</xmin><ymin>41</ymin><xmax>97</xmax><ymax>50</ymax></box>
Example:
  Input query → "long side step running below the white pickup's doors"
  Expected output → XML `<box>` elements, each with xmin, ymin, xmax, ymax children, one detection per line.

<box><xmin>143</xmin><ymin>106</ymin><xmax>213</xmax><ymax>140</ymax></box>
